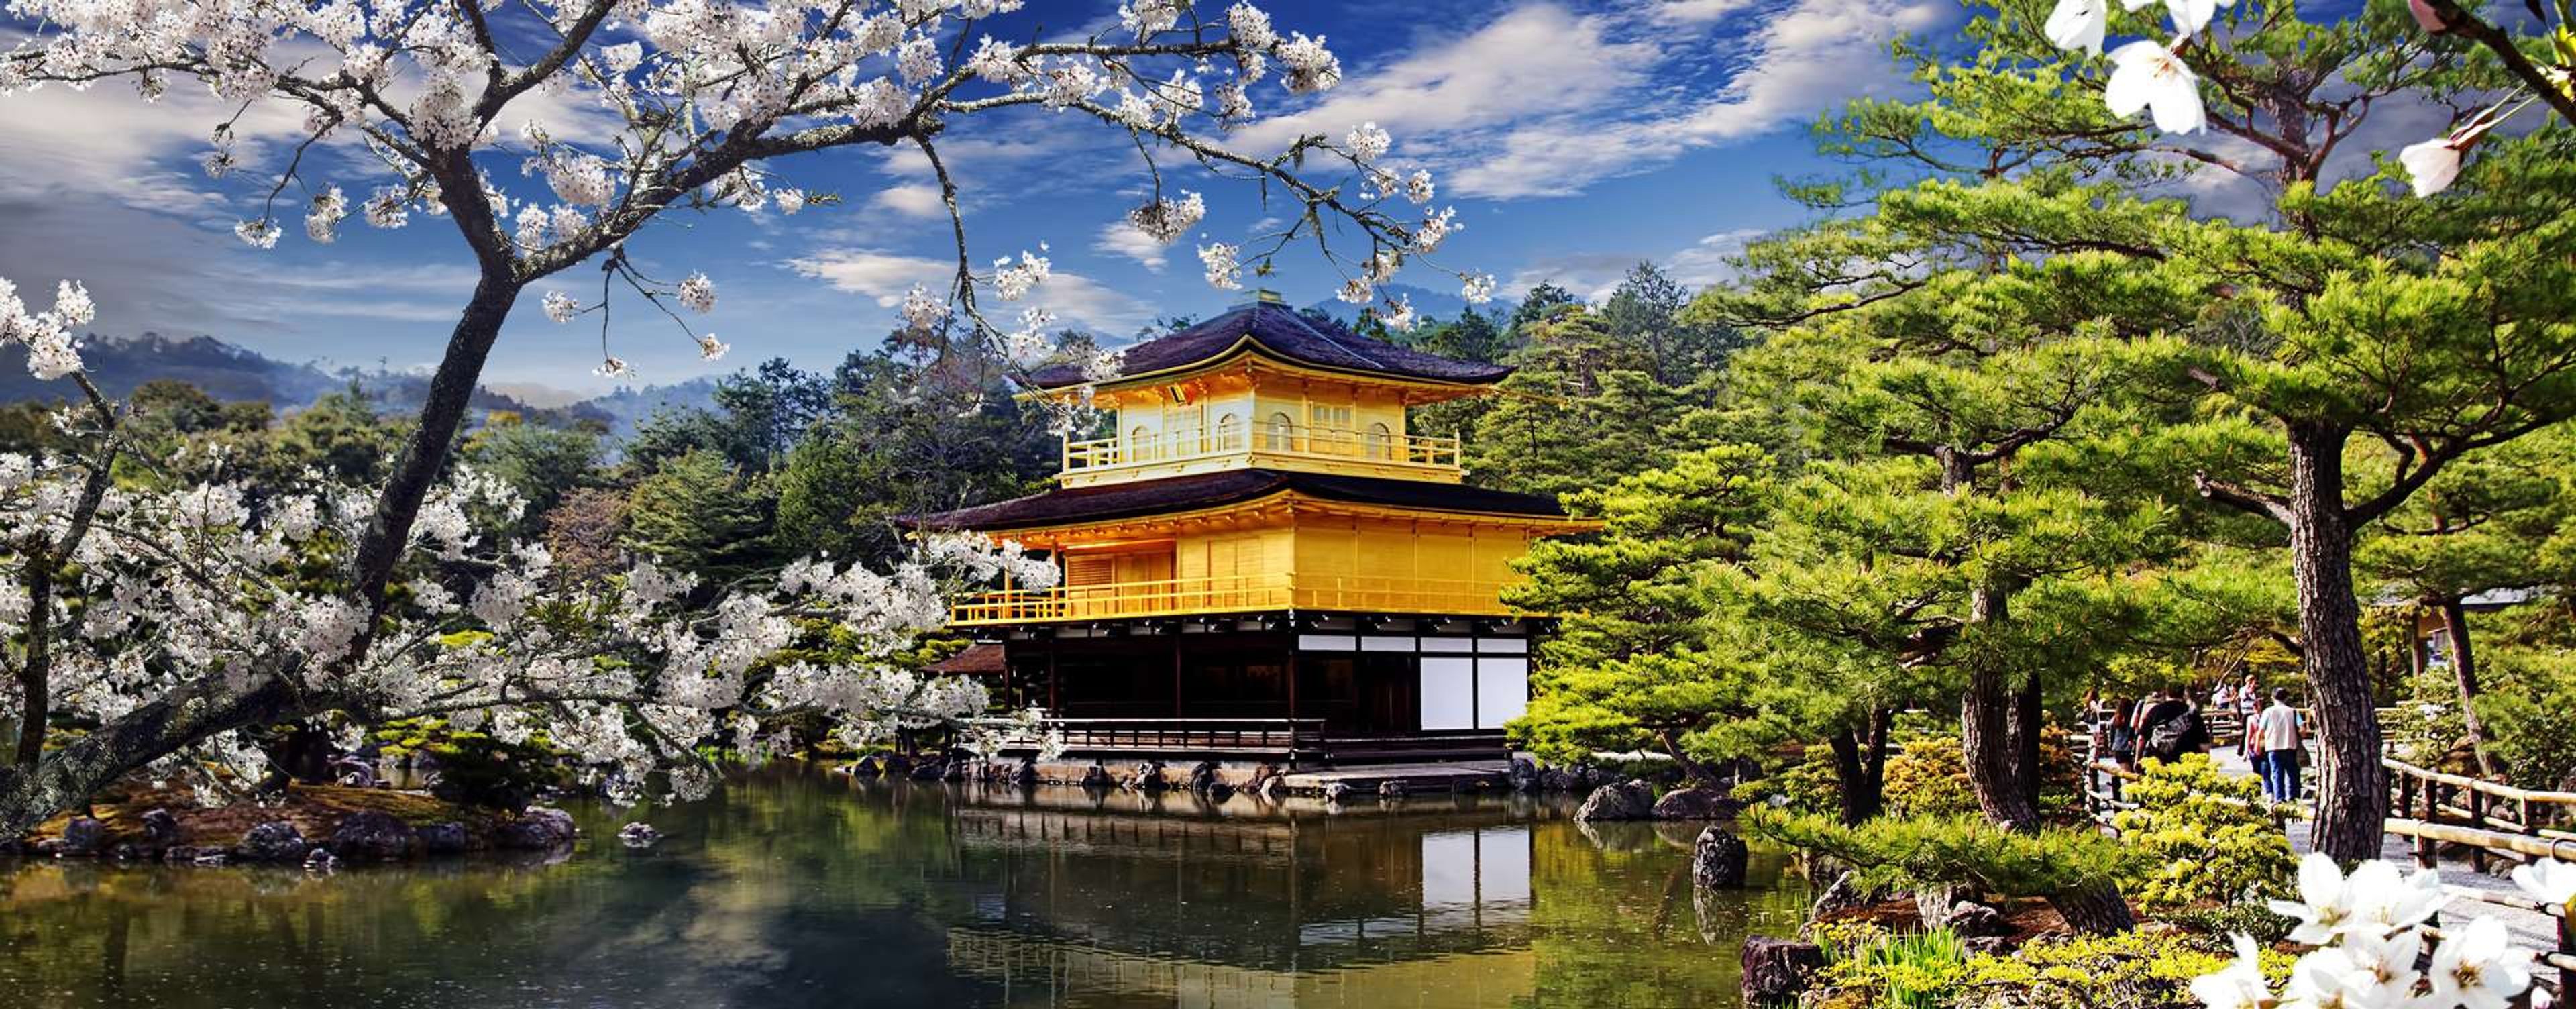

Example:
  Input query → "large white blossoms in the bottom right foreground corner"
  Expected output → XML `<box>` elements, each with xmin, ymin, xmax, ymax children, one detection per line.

<box><xmin>2192</xmin><ymin>855</ymin><xmax>2576</xmax><ymax>1009</ymax></box>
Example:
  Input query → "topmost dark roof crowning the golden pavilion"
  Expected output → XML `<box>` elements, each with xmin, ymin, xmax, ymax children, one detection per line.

<box><xmin>1028</xmin><ymin>301</ymin><xmax>1512</xmax><ymax>388</ymax></box>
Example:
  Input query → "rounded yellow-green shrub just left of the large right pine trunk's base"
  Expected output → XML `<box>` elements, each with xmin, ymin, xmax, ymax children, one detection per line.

<box><xmin>2112</xmin><ymin>754</ymin><xmax>2298</xmax><ymax>908</ymax></box>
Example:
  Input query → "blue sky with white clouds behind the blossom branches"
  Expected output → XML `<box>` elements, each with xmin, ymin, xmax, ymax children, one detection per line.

<box><xmin>0</xmin><ymin>0</ymin><xmax>1957</xmax><ymax>394</ymax></box>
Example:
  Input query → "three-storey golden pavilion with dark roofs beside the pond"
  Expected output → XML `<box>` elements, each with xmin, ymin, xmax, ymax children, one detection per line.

<box><xmin>917</xmin><ymin>291</ymin><xmax>1592</xmax><ymax>762</ymax></box>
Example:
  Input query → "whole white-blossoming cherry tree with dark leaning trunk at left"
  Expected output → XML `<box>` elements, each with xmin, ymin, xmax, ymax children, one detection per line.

<box><xmin>0</xmin><ymin>0</ymin><xmax>1494</xmax><ymax>834</ymax></box>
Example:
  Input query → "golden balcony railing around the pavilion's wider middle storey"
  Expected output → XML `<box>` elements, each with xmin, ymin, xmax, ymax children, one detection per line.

<box><xmin>948</xmin><ymin>572</ymin><xmax>1520</xmax><ymax>625</ymax></box>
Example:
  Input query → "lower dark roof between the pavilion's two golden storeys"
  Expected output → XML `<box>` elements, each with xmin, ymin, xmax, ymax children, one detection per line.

<box><xmin>910</xmin><ymin>468</ymin><xmax>1566</xmax><ymax>530</ymax></box>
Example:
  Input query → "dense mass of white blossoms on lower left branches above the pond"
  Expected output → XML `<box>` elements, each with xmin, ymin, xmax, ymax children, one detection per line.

<box><xmin>0</xmin><ymin>271</ymin><xmax>1056</xmax><ymax>798</ymax></box>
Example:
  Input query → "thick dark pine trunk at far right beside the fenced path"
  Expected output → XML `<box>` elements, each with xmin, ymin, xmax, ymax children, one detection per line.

<box><xmin>2288</xmin><ymin>425</ymin><xmax>2388</xmax><ymax>865</ymax></box>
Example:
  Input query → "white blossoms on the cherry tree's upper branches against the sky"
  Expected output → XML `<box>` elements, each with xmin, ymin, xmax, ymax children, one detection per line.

<box><xmin>0</xmin><ymin>0</ymin><xmax>1489</xmax><ymax>399</ymax></box>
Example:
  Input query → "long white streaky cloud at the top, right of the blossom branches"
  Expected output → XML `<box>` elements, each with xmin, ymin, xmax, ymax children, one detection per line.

<box><xmin>1239</xmin><ymin>0</ymin><xmax>1953</xmax><ymax>198</ymax></box>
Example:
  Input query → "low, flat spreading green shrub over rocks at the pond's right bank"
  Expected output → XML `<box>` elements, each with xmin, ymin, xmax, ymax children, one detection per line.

<box><xmin>1739</xmin><ymin>808</ymin><xmax>2135</xmax><ymax>896</ymax></box>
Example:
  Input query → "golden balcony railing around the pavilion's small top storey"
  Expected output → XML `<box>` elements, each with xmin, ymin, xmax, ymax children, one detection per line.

<box><xmin>1059</xmin><ymin>425</ymin><xmax>1466</xmax><ymax>486</ymax></box>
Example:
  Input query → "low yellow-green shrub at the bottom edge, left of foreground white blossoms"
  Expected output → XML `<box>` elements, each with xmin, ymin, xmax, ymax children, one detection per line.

<box><xmin>1953</xmin><ymin>932</ymin><xmax>2288</xmax><ymax>1009</ymax></box>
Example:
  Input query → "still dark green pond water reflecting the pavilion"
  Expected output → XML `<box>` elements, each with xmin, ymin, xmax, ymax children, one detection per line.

<box><xmin>0</xmin><ymin>765</ymin><xmax>1806</xmax><ymax>1009</ymax></box>
